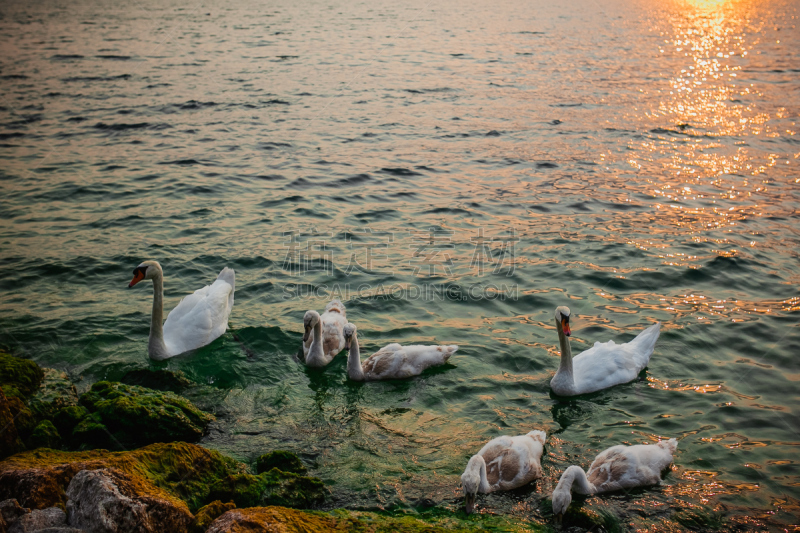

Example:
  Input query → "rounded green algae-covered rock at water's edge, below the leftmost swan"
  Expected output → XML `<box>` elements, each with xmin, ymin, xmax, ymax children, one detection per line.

<box><xmin>80</xmin><ymin>381</ymin><xmax>214</xmax><ymax>447</ymax></box>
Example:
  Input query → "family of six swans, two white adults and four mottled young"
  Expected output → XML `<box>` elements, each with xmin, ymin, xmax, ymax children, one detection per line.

<box><xmin>128</xmin><ymin>261</ymin><xmax>678</xmax><ymax>522</ymax></box>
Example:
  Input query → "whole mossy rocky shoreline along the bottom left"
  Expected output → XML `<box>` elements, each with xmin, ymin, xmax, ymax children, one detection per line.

<box><xmin>0</xmin><ymin>352</ymin><xmax>542</xmax><ymax>533</ymax></box>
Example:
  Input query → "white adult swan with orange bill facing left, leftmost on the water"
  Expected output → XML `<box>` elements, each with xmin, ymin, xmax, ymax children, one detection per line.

<box><xmin>128</xmin><ymin>261</ymin><xmax>236</xmax><ymax>361</ymax></box>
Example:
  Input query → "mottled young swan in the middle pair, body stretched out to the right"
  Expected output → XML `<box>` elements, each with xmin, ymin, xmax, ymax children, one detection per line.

<box><xmin>344</xmin><ymin>322</ymin><xmax>458</xmax><ymax>381</ymax></box>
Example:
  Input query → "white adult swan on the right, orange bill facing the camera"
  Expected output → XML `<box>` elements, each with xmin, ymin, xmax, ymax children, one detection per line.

<box><xmin>550</xmin><ymin>305</ymin><xmax>661</xmax><ymax>396</ymax></box>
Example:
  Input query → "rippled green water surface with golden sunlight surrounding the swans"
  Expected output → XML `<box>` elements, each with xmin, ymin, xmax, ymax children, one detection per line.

<box><xmin>0</xmin><ymin>0</ymin><xmax>800</xmax><ymax>531</ymax></box>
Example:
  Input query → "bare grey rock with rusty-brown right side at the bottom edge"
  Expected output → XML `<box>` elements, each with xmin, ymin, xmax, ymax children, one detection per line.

<box><xmin>67</xmin><ymin>468</ymin><xmax>192</xmax><ymax>533</ymax></box>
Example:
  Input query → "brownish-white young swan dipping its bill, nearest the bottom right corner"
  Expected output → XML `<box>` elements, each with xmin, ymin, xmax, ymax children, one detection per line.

<box><xmin>552</xmin><ymin>439</ymin><xmax>678</xmax><ymax>522</ymax></box>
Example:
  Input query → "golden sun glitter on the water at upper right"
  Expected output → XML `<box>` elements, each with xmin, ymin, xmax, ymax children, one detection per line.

<box><xmin>627</xmin><ymin>0</ymin><xmax>800</xmax><ymax>268</ymax></box>
